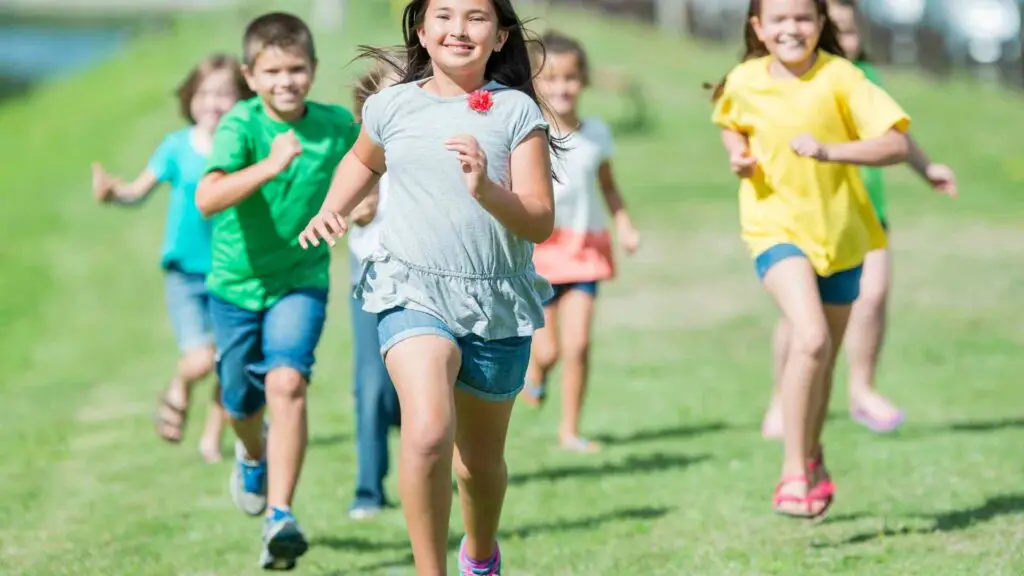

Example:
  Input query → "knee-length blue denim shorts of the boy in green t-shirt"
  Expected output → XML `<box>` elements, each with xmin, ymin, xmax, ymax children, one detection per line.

<box><xmin>210</xmin><ymin>289</ymin><xmax>327</xmax><ymax>420</ymax></box>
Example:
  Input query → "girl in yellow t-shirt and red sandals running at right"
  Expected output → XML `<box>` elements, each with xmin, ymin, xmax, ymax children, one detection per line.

<box><xmin>713</xmin><ymin>0</ymin><xmax>910</xmax><ymax>518</ymax></box>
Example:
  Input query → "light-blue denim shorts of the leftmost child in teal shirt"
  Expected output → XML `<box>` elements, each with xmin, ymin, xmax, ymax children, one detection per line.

<box><xmin>164</xmin><ymin>268</ymin><xmax>213</xmax><ymax>352</ymax></box>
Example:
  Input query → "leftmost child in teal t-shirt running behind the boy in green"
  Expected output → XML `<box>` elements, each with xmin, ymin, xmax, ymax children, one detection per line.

<box><xmin>92</xmin><ymin>54</ymin><xmax>252</xmax><ymax>462</ymax></box>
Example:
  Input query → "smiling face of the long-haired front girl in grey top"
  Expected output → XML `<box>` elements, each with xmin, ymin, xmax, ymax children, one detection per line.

<box><xmin>416</xmin><ymin>0</ymin><xmax>508</xmax><ymax>83</ymax></box>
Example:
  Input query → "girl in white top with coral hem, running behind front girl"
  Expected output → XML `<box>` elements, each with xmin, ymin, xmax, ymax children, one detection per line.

<box><xmin>522</xmin><ymin>32</ymin><xmax>640</xmax><ymax>452</ymax></box>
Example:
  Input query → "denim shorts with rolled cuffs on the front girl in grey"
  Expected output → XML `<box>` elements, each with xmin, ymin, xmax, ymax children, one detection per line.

<box><xmin>377</xmin><ymin>306</ymin><xmax>534</xmax><ymax>402</ymax></box>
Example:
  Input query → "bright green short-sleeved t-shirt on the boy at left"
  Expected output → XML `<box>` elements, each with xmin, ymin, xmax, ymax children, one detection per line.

<box><xmin>206</xmin><ymin>96</ymin><xmax>359</xmax><ymax>312</ymax></box>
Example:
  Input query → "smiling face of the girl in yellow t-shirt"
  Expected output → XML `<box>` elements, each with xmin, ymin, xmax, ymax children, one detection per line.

<box><xmin>751</xmin><ymin>0</ymin><xmax>824</xmax><ymax>69</ymax></box>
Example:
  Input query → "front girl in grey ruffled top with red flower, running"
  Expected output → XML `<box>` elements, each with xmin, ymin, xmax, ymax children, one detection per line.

<box><xmin>299</xmin><ymin>0</ymin><xmax>554</xmax><ymax>576</ymax></box>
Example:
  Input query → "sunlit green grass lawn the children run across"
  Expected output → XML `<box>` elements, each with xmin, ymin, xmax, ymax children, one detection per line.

<box><xmin>0</xmin><ymin>0</ymin><xmax>1024</xmax><ymax>576</ymax></box>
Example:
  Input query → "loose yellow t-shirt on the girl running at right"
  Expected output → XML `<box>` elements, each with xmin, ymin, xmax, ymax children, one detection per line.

<box><xmin>712</xmin><ymin>51</ymin><xmax>910</xmax><ymax>276</ymax></box>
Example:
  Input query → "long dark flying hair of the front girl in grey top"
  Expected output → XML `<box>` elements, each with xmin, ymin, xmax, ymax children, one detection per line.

<box><xmin>356</xmin><ymin>0</ymin><xmax>563</xmax><ymax>153</ymax></box>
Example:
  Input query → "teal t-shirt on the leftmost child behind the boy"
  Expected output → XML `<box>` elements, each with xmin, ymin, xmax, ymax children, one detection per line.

<box><xmin>147</xmin><ymin>127</ymin><xmax>211</xmax><ymax>275</ymax></box>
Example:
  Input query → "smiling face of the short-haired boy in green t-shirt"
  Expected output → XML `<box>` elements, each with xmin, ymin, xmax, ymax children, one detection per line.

<box><xmin>243</xmin><ymin>46</ymin><xmax>315</xmax><ymax>121</ymax></box>
